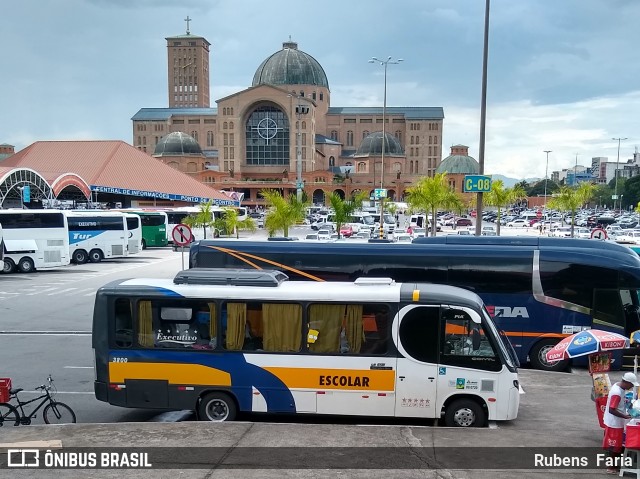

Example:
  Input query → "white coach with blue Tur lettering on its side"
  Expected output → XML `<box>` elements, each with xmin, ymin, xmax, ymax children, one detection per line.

<box><xmin>65</xmin><ymin>211</ymin><xmax>129</xmax><ymax>264</ymax></box>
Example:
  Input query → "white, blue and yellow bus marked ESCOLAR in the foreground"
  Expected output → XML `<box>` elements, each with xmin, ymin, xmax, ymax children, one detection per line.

<box><xmin>93</xmin><ymin>268</ymin><xmax>520</xmax><ymax>427</ymax></box>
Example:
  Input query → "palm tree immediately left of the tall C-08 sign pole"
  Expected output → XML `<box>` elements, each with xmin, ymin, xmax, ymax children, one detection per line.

<box><xmin>407</xmin><ymin>173</ymin><xmax>464</xmax><ymax>236</ymax></box>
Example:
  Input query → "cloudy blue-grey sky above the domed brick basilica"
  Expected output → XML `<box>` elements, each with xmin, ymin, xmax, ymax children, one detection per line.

<box><xmin>0</xmin><ymin>0</ymin><xmax>640</xmax><ymax>178</ymax></box>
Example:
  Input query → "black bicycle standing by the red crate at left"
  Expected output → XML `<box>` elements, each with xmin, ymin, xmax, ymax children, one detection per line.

<box><xmin>0</xmin><ymin>374</ymin><xmax>76</xmax><ymax>427</ymax></box>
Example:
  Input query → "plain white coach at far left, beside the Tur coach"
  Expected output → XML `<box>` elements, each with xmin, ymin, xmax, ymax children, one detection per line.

<box><xmin>0</xmin><ymin>209</ymin><xmax>69</xmax><ymax>273</ymax></box>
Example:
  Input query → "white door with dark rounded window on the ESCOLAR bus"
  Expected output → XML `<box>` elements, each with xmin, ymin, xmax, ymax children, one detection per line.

<box><xmin>394</xmin><ymin>305</ymin><xmax>440</xmax><ymax>417</ymax></box>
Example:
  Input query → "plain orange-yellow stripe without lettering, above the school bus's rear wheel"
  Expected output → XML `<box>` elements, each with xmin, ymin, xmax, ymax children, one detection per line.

<box><xmin>109</xmin><ymin>362</ymin><xmax>231</xmax><ymax>386</ymax></box>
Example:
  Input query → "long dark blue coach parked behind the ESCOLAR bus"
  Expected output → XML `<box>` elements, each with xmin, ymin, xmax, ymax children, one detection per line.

<box><xmin>189</xmin><ymin>236</ymin><xmax>640</xmax><ymax>370</ymax></box>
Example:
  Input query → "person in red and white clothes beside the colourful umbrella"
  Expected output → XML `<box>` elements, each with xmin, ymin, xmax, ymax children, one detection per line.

<box><xmin>602</xmin><ymin>373</ymin><xmax>640</xmax><ymax>474</ymax></box>
